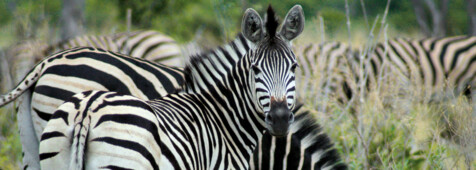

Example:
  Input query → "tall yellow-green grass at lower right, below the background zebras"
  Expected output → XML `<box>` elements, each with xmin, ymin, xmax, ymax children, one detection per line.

<box><xmin>295</xmin><ymin>24</ymin><xmax>476</xmax><ymax>169</ymax></box>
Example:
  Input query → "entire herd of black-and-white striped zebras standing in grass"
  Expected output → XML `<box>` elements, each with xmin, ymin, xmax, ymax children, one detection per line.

<box><xmin>0</xmin><ymin>5</ymin><xmax>476</xmax><ymax>169</ymax></box>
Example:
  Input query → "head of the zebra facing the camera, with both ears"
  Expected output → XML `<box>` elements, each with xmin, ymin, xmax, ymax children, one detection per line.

<box><xmin>242</xmin><ymin>5</ymin><xmax>304</xmax><ymax>136</ymax></box>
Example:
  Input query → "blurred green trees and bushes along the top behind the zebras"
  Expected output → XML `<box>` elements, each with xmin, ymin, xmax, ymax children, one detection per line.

<box><xmin>0</xmin><ymin>0</ymin><xmax>469</xmax><ymax>46</ymax></box>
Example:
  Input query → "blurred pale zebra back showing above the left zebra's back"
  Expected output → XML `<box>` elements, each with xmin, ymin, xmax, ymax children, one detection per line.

<box><xmin>40</xmin><ymin>30</ymin><xmax>184</xmax><ymax>67</ymax></box>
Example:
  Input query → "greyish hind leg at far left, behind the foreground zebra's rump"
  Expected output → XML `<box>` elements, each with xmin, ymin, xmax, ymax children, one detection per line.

<box><xmin>17</xmin><ymin>90</ymin><xmax>40</xmax><ymax>169</ymax></box>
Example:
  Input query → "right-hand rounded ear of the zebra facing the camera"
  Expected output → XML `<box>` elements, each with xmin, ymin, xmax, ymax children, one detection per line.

<box><xmin>279</xmin><ymin>5</ymin><xmax>304</xmax><ymax>41</ymax></box>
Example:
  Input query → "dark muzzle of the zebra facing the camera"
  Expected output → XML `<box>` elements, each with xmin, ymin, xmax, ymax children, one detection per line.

<box><xmin>265</xmin><ymin>100</ymin><xmax>294</xmax><ymax>136</ymax></box>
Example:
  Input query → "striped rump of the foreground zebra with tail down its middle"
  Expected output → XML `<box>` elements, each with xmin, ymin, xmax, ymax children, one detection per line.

<box><xmin>40</xmin><ymin>91</ymin><xmax>162</xmax><ymax>169</ymax></box>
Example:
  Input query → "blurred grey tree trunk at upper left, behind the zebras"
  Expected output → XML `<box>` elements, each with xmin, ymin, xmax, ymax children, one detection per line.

<box><xmin>61</xmin><ymin>0</ymin><xmax>84</xmax><ymax>40</ymax></box>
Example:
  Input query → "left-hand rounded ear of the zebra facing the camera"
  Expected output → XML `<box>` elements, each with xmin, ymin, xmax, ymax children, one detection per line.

<box><xmin>241</xmin><ymin>8</ymin><xmax>264</xmax><ymax>43</ymax></box>
